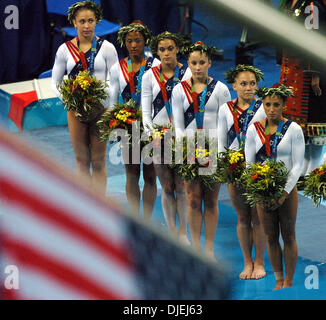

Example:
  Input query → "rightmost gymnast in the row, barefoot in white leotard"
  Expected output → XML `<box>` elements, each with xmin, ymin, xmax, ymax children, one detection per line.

<box><xmin>245</xmin><ymin>85</ymin><xmax>305</xmax><ymax>290</ymax></box>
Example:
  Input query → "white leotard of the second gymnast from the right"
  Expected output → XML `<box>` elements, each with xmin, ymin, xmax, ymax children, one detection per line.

<box><xmin>218</xmin><ymin>100</ymin><xmax>266</xmax><ymax>152</ymax></box>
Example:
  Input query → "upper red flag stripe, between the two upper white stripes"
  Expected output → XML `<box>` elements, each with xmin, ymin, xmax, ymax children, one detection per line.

<box><xmin>0</xmin><ymin>178</ymin><xmax>132</xmax><ymax>269</ymax></box>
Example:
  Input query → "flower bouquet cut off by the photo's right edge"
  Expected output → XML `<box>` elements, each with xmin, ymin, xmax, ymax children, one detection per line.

<box><xmin>304</xmin><ymin>164</ymin><xmax>326</xmax><ymax>207</ymax></box>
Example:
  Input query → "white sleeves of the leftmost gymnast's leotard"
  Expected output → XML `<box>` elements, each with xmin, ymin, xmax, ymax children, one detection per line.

<box><xmin>52</xmin><ymin>39</ymin><xmax>118</xmax><ymax>107</ymax></box>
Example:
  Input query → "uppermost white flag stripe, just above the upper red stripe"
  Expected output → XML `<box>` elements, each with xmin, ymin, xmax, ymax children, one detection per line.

<box><xmin>0</xmin><ymin>144</ymin><xmax>125</xmax><ymax>244</ymax></box>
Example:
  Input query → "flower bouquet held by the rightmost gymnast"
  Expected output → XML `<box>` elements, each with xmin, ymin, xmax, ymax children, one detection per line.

<box><xmin>241</xmin><ymin>160</ymin><xmax>289</xmax><ymax>207</ymax></box>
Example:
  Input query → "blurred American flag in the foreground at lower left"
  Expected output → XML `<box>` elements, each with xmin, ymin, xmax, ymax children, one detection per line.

<box><xmin>0</xmin><ymin>130</ymin><xmax>229</xmax><ymax>300</ymax></box>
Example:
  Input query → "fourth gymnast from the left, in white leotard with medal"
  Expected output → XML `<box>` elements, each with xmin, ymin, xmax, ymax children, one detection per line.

<box><xmin>172</xmin><ymin>42</ymin><xmax>231</xmax><ymax>260</ymax></box>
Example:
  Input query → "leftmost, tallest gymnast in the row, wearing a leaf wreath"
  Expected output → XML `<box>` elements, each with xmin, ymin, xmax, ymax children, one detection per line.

<box><xmin>52</xmin><ymin>1</ymin><xmax>118</xmax><ymax>194</ymax></box>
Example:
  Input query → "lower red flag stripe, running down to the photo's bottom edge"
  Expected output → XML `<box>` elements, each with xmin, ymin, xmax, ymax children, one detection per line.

<box><xmin>1</xmin><ymin>234</ymin><xmax>130</xmax><ymax>300</ymax></box>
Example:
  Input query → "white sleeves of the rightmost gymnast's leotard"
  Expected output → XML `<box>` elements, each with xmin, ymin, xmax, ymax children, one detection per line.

<box><xmin>245</xmin><ymin>121</ymin><xmax>305</xmax><ymax>193</ymax></box>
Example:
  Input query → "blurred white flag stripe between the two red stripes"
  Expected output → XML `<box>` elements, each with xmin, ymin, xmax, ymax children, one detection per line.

<box><xmin>2</xmin><ymin>204</ymin><xmax>137</xmax><ymax>298</ymax></box>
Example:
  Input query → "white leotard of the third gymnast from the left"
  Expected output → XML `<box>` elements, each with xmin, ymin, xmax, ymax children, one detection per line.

<box><xmin>141</xmin><ymin>65</ymin><xmax>191</xmax><ymax>131</ymax></box>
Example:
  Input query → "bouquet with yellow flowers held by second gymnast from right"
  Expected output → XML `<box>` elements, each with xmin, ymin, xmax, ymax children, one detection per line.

<box><xmin>217</xmin><ymin>149</ymin><xmax>246</xmax><ymax>184</ymax></box>
